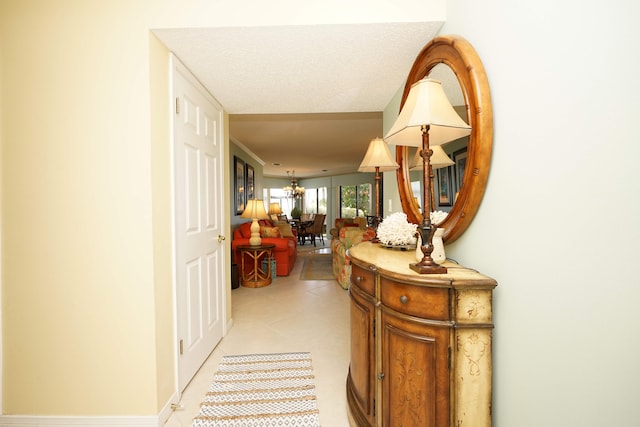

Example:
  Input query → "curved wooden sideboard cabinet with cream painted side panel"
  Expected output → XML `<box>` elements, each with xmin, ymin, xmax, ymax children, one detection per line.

<box><xmin>347</xmin><ymin>242</ymin><xmax>496</xmax><ymax>427</ymax></box>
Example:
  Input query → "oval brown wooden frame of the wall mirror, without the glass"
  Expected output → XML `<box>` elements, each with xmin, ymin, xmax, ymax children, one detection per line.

<box><xmin>396</xmin><ymin>36</ymin><xmax>493</xmax><ymax>243</ymax></box>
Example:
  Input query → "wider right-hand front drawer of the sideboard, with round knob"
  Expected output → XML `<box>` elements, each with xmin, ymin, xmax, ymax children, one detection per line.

<box><xmin>380</xmin><ymin>278</ymin><xmax>451</xmax><ymax>320</ymax></box>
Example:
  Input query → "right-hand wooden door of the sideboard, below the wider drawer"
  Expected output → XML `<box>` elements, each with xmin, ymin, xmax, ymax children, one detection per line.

<box><xmin>381</xmin><ymin>312</ymin><xmax>450</xmax><ymax>427</ymax></box>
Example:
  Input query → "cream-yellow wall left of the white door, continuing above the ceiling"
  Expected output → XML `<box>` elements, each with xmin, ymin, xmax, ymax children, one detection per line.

<box><xmin>0</xmin><ymin>0</ymin><xmax>445</xmax><ymax>416</ymax></box>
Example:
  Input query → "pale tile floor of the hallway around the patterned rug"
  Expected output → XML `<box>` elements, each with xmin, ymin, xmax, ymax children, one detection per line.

<box><xmin>165</xmin><ymin>239</ymin><xmax>349</xmax><ymax>427</ymax></box>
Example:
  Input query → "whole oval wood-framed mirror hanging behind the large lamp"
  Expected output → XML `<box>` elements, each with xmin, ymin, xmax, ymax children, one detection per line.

<box><xmin>396</xmin><ymin>36</ymin><xmax>493</xmax><ymax>243</ymax></box>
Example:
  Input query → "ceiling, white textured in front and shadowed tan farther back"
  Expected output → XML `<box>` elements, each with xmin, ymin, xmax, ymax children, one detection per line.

<box><xmin>154</xmin><ymin>21</ymin><xmax>442</xmax><ymax>178</ymax></box>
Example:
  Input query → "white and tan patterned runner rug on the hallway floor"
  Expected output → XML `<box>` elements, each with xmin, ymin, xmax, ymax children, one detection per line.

<box><xmin>192</xmin><ymin>352</ymin><xmax>320</xmax><ymax>427</ymax></box>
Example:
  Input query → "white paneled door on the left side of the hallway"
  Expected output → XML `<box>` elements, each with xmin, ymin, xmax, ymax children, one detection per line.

<box><xmin>172</xmin><ymin>58</ymin><xmax>227</xmax><ymax>392</ymax></box>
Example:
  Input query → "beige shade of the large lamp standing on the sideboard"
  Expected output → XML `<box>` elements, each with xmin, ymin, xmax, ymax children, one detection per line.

<box><xmin>384</xmin><ymin>78</ymin><xmax>471</xmax><ymax>147</ymax></box>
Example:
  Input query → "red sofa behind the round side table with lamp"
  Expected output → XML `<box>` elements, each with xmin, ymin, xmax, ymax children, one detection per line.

<box><xmin>231</xmin><ymin>220</ymin><xmax>298</xmax><ymax>276</ymax></box>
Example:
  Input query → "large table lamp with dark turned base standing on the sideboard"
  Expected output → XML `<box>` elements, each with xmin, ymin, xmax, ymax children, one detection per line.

<box><xmin>384</xmin><ymin>78</ymin><xmax>471</xmax><ymax>274</ymax></box>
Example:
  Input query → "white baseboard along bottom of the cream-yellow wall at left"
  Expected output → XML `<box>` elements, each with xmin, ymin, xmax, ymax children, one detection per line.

<box><xmin>0</xmin><ymin>415</ymin><xmax>159</xmax><ymax>427</ymax></box>
